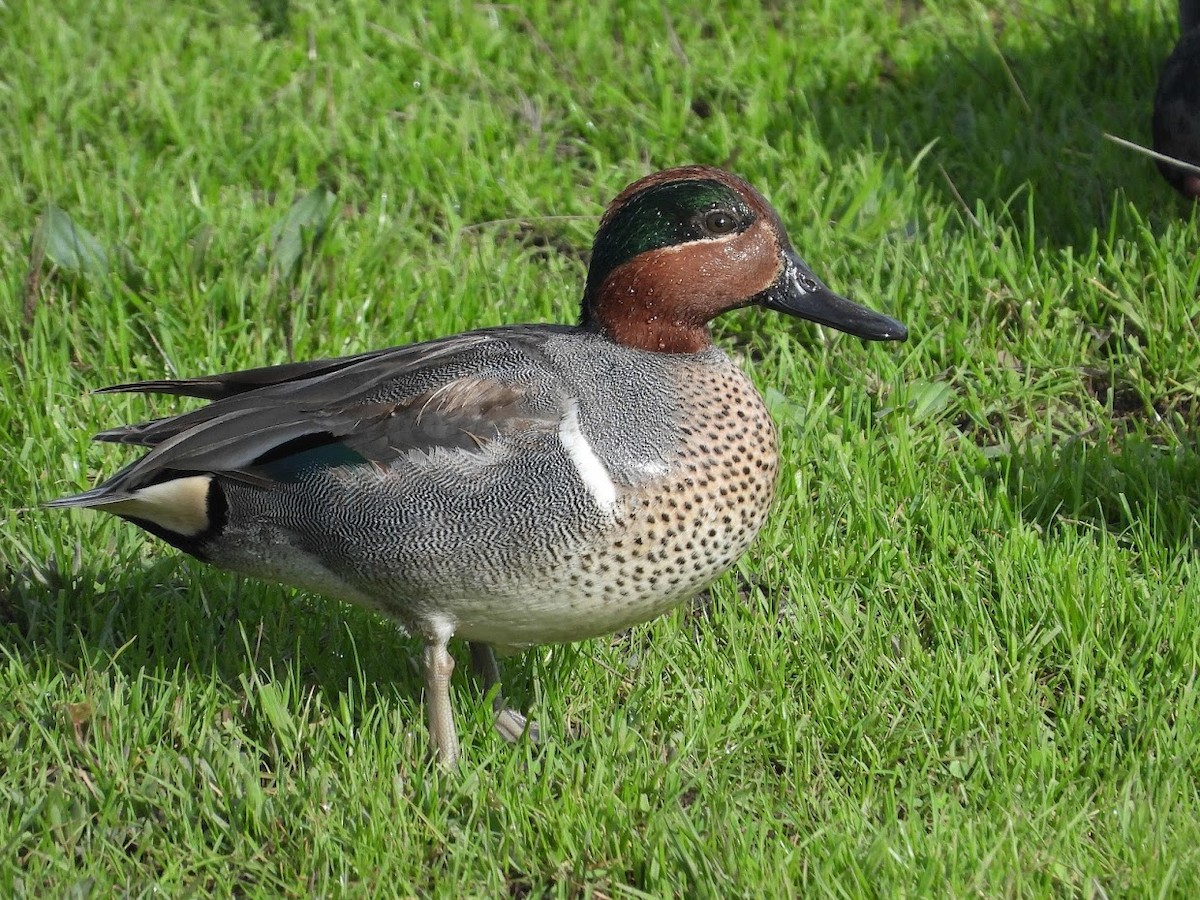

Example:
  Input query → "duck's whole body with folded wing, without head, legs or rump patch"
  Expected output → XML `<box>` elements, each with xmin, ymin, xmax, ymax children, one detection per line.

<box><xmin>60</xmin><ymin>326</ymin><xmax>776</xmax><ymax>648</ymax></box>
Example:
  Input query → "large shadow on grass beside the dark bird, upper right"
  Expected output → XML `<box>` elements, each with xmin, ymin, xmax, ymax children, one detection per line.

<box><xmin>782</xmin><ymin>2</ymin><xmax>1187</xmax><ymax>246</ymax></box>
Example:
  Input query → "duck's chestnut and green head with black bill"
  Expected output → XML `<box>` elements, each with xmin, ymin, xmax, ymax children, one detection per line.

<box><xmin>581</xmin><ymin>166</ymin><xmax>908</xmax><ymax>353</ymax></box>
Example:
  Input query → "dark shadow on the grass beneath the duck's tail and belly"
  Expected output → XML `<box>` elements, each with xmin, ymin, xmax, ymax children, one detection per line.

<box><xmin>0</xmin><ymin>542</ymin><xmax>535</xmax><ymax>716</ymax></box>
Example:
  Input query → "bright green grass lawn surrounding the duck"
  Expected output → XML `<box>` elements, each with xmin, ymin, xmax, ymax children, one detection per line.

<box><xmin>0</xmin><ymin>0</ymin><xmax>1200</xmax><ymax>896</ymax></box>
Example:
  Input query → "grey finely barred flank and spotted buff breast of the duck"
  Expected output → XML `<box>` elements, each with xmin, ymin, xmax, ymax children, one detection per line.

<box><xmin>198</xmin><ymin>332</ymin><xmax>775</xmax><ymax>646</ymax></box>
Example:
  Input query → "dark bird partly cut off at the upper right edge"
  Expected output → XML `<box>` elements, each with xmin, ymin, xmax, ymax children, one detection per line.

<box><xmin>1152</xmin><ymin>0</ymin><xmax>1200</xmax><ymax>199</ymax></box>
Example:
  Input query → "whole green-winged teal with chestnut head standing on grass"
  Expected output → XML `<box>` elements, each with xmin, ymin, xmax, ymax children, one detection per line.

<box><xmin>49</xmin><ymin>166</ymin><xmax>906</xmax><ymax>763</ymax></box>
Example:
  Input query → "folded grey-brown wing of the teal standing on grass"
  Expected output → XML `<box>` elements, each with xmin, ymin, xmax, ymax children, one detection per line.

<box><xmin>47</xmin><ymin>328</ymin><xmax>565</xmax><ymax>511</ymax></box>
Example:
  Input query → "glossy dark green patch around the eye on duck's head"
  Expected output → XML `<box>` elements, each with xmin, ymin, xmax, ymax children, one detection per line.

<box><xmin>587</xmin><ymin>179</ymin><xmax>750</xmax><ymax>298</ymax></box>
